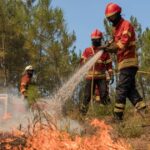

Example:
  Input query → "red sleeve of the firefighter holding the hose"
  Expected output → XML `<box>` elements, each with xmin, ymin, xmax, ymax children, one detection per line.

<box><xmin>116</xmin><ymin>22</ymin><xmax>134</xmax><ymax>49</ymax></box>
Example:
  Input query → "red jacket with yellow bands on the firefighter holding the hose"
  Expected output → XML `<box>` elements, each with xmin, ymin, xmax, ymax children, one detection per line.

<box><xmin>113</xmin><ymin>18</ymin><xmax>138</xmax><ymax>70</ymax></box>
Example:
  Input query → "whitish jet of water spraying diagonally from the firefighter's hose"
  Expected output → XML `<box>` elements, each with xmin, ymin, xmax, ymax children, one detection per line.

<box><xmin>48</xmin><ymin>51</ymin><xmax>103</xmax><ymax>116</ymax></box>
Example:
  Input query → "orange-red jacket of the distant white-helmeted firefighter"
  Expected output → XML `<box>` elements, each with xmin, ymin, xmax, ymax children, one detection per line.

<box><xmin>20</xmin><ymin>74</ymin><xmax>31</xmax><ymax>95</ymax></box>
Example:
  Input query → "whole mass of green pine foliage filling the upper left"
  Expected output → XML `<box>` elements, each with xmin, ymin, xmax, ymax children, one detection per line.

<box><xmin>0</xmin><ymin>0</ymin><xmax>79</xmax><ymax>94</ymax></box>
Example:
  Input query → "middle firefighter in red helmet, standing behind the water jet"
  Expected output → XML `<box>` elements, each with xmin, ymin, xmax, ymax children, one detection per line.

<box><xmin>80</xmin><ymin>29</ymin><xmax>112</xmax><ymax>115</ymax></box>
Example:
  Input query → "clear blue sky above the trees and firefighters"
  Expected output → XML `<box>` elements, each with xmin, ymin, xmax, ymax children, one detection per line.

<box><xmin>51</xmin><ymin>0</ymin><xmax>150</xmax><ymax>52</ymax></box>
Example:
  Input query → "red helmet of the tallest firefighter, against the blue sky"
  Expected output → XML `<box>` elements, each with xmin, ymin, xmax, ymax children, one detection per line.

<box><xmin>105</xmin><ymin>3</ymin><xmax>121</xmax><ymax>17</ymax></box>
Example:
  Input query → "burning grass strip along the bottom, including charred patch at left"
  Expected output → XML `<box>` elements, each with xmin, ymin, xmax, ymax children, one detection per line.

<box><xmin>0</xmin><ymin>115</ymin><xmax>130</xmax><ymax>150</ymax></box>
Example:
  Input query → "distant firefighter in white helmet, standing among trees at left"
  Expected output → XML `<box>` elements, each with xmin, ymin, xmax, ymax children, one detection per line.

<box><xmin>20</xmin><ymin>65</ymin><xmax>34</xmax><ymax>98</ymax></box>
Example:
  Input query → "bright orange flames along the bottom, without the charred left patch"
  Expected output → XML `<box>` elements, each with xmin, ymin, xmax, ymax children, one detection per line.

<box><xmin>25</xmin><ymin>119</ymin><xmax>130</xmax><ymax>150</ymax></box>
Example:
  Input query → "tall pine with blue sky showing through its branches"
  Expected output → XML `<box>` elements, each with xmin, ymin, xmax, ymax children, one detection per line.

<box><xmin>25</xmin><ymin>0</ymin><xmax>78</xmax><ymax>92</ymax></box>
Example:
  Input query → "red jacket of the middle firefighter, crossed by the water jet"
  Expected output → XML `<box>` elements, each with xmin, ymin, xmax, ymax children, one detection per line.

<box><xmin>81</xmin><ymin>46</ymin><xmax>112</xmax><ymax>80</ymax></box>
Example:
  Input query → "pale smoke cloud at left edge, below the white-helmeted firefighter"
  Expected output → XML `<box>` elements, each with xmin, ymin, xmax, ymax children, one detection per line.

<box><xmin>0</xmin><ymin>89</ymin><xmax>32</xmax><ymax>131</ymax></box>
